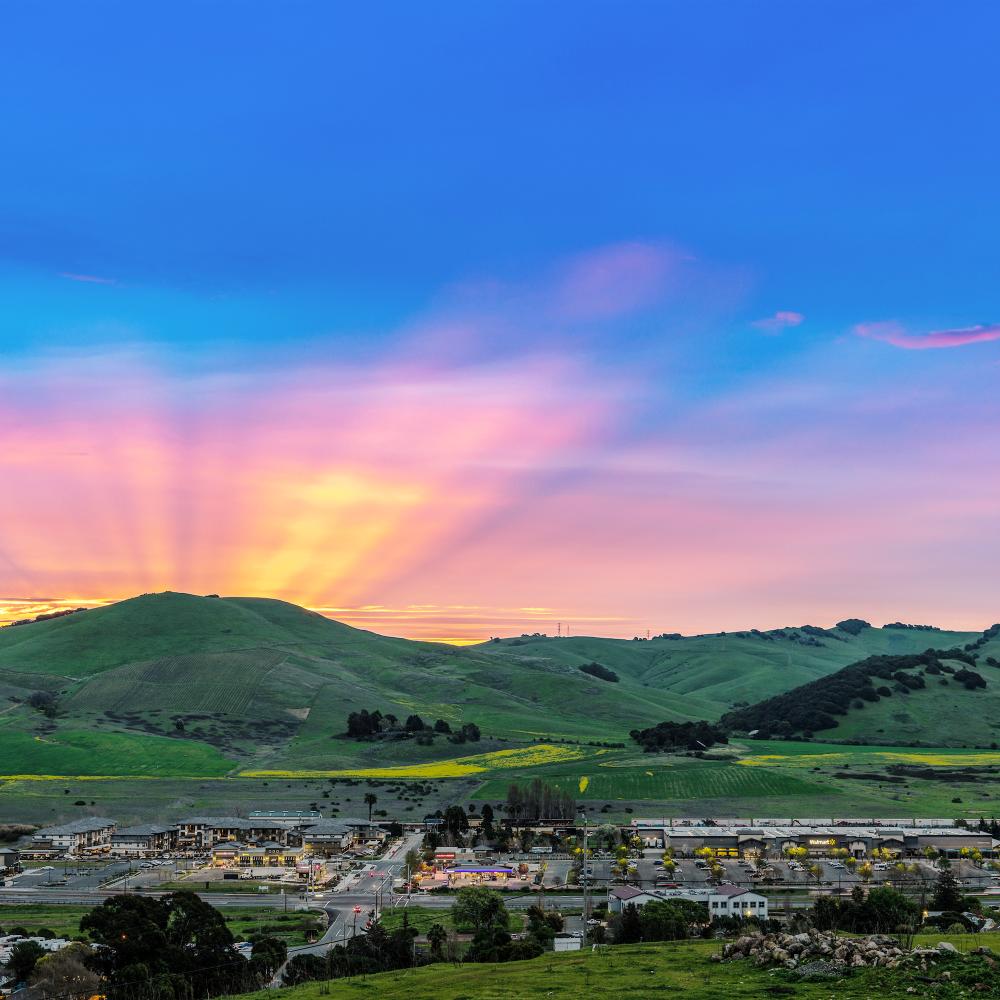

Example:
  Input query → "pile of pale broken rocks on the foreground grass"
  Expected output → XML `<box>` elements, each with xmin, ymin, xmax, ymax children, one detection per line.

<box><xmin>716</xmin><ymin>930</ymin><xmax>988</xmax><ymax>977</ymax></box>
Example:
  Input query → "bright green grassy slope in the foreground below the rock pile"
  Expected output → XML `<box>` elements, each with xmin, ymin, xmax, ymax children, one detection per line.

<box><xmin>232</xmin><ymin>941</ymin><xmax>976</xmax><ymax>1000</ymax></box>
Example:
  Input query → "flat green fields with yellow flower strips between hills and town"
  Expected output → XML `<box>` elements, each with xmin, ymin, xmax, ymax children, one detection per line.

<box><xmin>0</xmin><ymin>741</ymin><xmax>1000</xmax><ymax>824</ymax></box>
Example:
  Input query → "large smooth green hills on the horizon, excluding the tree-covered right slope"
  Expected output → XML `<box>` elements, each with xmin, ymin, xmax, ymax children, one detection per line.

<box><xmin>0</xmin><ymin>592</ymin><xmax>978</xmax><ymax>777</ymax></box>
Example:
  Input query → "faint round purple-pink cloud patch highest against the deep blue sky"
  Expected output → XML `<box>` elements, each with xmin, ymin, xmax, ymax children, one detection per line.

<box><xmin>553</xmin><ymin>242</ymin><xmax>691</xmax><ymax>319</ymax></box>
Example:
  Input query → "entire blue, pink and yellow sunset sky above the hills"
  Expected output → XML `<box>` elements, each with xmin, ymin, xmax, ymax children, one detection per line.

<box><xmin>0</xmin><ymin>0</ymin><xmax>1000</xmax><ymax>642</ymax></box>
